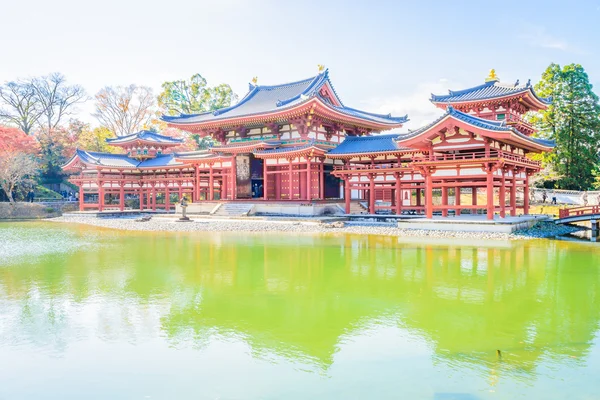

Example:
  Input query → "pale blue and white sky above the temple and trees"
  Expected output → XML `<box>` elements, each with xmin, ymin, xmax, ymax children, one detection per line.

<box><xmin>0</xmin><ymin>0</ymin><xmax>600</xmax><ymax>129</ymax></box>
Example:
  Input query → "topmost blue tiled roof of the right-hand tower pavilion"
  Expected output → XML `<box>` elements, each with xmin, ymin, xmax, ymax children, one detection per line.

<box><xmin>431</xmin><ymin>81</ymin><xmax>550</xmax><ymax>104</ymax></box>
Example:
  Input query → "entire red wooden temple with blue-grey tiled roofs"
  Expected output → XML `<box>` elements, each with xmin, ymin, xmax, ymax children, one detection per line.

<box><xmin>64</xmin><ymin>70</ymin><xmax>553</xmax><ymax>219</ymax></box>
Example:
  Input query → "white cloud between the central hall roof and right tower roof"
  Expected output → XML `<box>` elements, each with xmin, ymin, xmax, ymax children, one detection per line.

<box><xmin>362</xmin><ymin>78</ymin><xmax>466</xmax><ymax>132</ymax></box>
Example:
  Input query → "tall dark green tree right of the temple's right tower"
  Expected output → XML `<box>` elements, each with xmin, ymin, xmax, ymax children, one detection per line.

<box><xmin>534</xmin><ymin>64</ymin><xmax>600</xmax><ymax>190</ymax></box>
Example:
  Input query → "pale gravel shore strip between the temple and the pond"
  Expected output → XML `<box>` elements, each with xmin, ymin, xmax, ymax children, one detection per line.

<box><xmin>50</xmin><ymin>216</ymin><xmax>578</xmax><ymax>240</ymax></box>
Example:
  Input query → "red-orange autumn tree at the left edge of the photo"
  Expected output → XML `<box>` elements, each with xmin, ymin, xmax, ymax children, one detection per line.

<box><xmin>0</xmin><ymin>126</ymin><xmax>38</xmax><ymax>203</ymax></box>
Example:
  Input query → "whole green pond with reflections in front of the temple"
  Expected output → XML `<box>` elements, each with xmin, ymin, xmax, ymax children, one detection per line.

<box><xmin>0</xmin><ymin>222</ymin><xmax>600</xmax><ymax>400</ymax></box>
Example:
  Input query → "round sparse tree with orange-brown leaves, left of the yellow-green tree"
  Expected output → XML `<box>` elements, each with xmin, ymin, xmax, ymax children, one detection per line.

<box><xmin>93</xmin><ymin>85</ymin><xmax>156</xmax><ymax>136</ymax></box>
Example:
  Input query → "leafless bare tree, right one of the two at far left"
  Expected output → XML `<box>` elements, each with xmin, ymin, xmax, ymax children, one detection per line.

<box><xmin>31</xmin><ymin>72</ymin><xmax>87</xmax><ymax>131</ymax></box>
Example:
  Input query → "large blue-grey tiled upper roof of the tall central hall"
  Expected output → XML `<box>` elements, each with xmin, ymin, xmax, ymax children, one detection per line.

<box><xmin>161</xmin><ymin>70</ymin><xmax>407</xmax><ymax>124</ymax></box>
